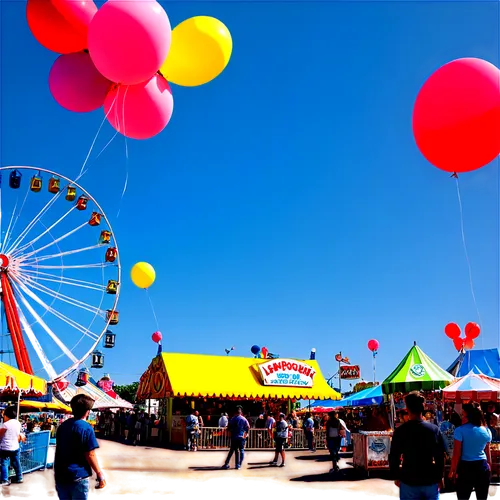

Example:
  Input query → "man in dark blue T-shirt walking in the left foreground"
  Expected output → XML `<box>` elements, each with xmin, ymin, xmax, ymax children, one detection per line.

<box><xmin>54</xmin><ymin>394</ymin><xmax>106</xmax><ymax>500</ymax></box>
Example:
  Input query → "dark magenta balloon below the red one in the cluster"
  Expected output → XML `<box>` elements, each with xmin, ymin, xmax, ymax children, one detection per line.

<box><xmin>49</xmin><ymin>52</ymin><xmax>112</xmax><ymax>113</ymax></box>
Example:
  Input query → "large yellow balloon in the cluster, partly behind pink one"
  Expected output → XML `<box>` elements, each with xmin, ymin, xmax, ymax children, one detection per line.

<box><xmin>160</xmin><ymin>16</ymin><xmax>233</xmax><ymax>87</ymax></box>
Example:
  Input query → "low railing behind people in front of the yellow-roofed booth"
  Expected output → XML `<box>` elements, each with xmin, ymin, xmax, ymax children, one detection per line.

<box><xmin>197</xmin><ymin>427</ymin><xmax>326</xmax><ymax>450</ymax></box>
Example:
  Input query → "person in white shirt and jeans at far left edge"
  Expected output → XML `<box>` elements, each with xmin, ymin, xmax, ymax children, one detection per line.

<box><xmin>0</xmin><ymin>406</ymin><xmax>26</xmax><ymax>486</ymax></box>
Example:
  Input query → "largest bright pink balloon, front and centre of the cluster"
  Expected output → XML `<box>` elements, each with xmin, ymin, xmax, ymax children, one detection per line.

<box><xmin>88</xmin><ymin>0</ymin><xmax>172</xmax><ymax>85</ymax></box>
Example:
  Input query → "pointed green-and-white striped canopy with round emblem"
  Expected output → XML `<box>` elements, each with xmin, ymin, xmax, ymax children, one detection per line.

<box><xmin>382</xmin><ymin>343</ymin><xmax>454</xmax><ymax>394</ymax></box>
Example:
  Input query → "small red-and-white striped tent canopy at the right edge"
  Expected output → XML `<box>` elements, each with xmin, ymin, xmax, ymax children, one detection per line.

<box><xmin>443</xmin><ymin>370</ymin><xmax>500</xmax><ymax>402</ymax></box>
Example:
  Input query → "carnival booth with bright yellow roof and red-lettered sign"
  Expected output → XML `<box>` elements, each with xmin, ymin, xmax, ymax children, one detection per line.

<box><xmin>137</xmin><ymin>353</ymin><xmax>340</xmax><ymax>448</ymax></box>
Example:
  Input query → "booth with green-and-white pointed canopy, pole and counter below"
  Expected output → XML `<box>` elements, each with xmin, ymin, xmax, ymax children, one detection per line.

<box><xmin>353</xmin><ymin>342</ymin><xmax>453</xmax><ymax>473</ymax></box>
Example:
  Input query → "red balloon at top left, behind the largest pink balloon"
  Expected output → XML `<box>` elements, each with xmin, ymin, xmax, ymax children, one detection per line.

<box><xmin>26</xmin><ymin>0</ymin><xmax>87</xmax><ymax>54</ymax></box>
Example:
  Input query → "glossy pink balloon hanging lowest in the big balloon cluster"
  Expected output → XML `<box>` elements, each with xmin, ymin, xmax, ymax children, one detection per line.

<box><xmin>104</xmin><ymin>75</ymin><xmax>174</xmax><ymax>139</ymax></box>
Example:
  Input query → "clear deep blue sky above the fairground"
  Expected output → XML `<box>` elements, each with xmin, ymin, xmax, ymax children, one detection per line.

<box><xmin>1</xmin><ymin>2</ymin><xmax>499</xmax><ymax>383</ymax></box>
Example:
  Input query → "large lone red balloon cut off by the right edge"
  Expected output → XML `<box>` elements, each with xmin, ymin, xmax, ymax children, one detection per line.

<box><xmin>413</xmin><ymin>58</ymin><xmax>500</xmax><ymax>172</ymax></box>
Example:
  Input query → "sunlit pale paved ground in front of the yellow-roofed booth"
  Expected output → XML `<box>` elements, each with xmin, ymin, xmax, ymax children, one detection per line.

<box><xmin>1</xmin><ymin>440</ymin><xmax>397</xmax><ymax>498</ymax></box>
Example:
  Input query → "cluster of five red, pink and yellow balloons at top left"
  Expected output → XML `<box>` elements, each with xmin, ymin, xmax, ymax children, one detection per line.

<box><xmin>26</xmin><ymin>0</ymin><xmax>232</xmax><ymax>139</ymax></box>
